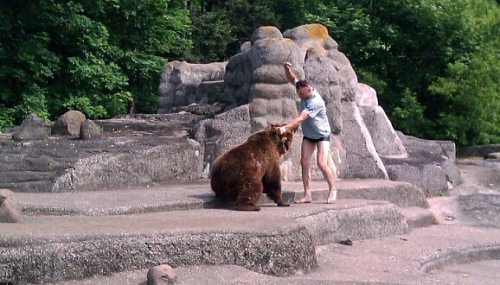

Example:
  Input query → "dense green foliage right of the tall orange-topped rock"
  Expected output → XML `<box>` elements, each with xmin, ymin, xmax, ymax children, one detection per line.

<box><xmin>300</xmin><ymin>0</ymin><xmax>500</xmax><ymax>145</ymax></box>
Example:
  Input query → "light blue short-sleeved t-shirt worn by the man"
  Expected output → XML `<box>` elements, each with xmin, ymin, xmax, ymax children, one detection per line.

<box><xmin>300</xmin><ymin>89</ymin><xmax>332</xmax><ymax>139</ymax></box>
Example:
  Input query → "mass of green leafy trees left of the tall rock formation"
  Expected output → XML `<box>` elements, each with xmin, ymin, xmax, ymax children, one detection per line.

<box><xmin>0</xmin><ymin>0</ymin><xmax>192</xmax><ymax>128</ymax></box>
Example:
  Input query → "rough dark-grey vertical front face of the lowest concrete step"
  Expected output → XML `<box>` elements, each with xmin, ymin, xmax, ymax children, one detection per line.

<box><xmin>0</xmin><ymin>223</ymin><xmax>316</xmax><ymax>284</ymax></box>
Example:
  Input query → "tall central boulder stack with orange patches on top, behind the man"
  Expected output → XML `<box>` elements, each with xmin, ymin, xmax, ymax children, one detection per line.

<box><xmin>207</xmin><ymin>24</ymin><xmax>387</xmax><ymax>180</ymax></box>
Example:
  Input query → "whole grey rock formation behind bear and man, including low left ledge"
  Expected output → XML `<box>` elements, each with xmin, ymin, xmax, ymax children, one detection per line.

<box><xmin>0</xmin><ymin>24</ymin><xmax>461</xmax><ymax>195</ymax></box>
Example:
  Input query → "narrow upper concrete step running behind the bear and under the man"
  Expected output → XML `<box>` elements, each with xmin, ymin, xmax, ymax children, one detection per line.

<box><xmin>16</xmin><ymin>179</ymin><xmax>428</xmax><ymax>216</ymax></box>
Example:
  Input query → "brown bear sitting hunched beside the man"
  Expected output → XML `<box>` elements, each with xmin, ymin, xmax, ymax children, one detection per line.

<box><xmin>210</xmin><ymin>125</ymin><xmax>293</xmax><ymax>211</ymax></box>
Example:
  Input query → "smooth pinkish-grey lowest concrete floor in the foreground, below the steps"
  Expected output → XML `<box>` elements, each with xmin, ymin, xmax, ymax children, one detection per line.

<box><xmin>41</xmin><ymin>225</ymin><xmax>500</xmax><ymax>285</ymax></box>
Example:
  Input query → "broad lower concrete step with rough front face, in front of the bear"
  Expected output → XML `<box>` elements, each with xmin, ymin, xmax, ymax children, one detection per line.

<box><xmin>0</xmin><ymin>200</ymin><xmax>408</xmax><ymax>284</ymax></box>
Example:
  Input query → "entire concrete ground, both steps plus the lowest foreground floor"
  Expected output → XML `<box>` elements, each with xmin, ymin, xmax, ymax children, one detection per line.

<box><xmin>0</xmin><ymin>161</ymin><xmax>500</xmax><ymax>285</ymax></box>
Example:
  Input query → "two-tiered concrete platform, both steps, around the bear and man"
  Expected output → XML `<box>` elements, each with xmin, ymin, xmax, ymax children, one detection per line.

<box><xmin>0</xmin><ymin>180</ymin><xmax>427</xmax><ymax>283</ymax></box>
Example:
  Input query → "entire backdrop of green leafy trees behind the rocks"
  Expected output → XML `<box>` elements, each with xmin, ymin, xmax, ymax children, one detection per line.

<box><xmin>0</xmin><ymin>0</ymin><xmax>500</xmax><ymax>145</ymax></box>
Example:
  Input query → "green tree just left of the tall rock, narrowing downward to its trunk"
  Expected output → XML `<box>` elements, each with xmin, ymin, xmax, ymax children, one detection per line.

<box><xmin>85</xmin><ymin>0</ymin><xmax>192</xmax><ymax>113</ymax></box>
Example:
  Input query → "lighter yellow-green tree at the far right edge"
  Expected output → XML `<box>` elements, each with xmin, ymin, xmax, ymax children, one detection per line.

<box><xmin>430</xmin><ymin>0</ymin><xmax>500</xmax><ymax>145</ymax></box>
